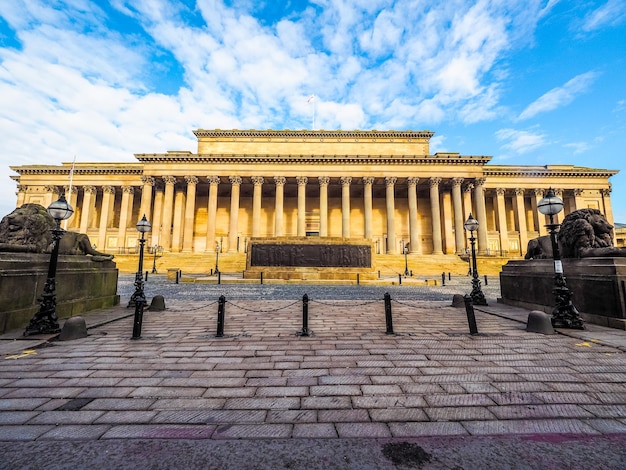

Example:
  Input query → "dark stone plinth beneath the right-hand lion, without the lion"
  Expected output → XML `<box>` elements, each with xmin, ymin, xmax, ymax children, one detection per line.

<box><xmin>499</xmin><ymin>258</ymin><xmax>626</xmax><ymax>329</ymax></box>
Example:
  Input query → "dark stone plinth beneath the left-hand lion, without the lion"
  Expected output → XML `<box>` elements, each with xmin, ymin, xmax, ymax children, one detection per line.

<box><xmin>0</xmin><ymin>253</ymin><xmax>120</xmax><ymax>333</ymax></box>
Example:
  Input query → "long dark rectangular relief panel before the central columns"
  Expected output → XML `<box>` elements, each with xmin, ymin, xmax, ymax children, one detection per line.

<box><xmin>250</xmin><ymin>243</ymin><xmax>372</xmax><ymax>268</ymax></box>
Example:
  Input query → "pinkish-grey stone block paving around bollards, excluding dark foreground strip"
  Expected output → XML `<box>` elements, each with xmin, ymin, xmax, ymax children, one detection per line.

<box><xmin>0</xmin><ymin>299</ymin><xmax>626</xmax><ymax>441</ymax></box>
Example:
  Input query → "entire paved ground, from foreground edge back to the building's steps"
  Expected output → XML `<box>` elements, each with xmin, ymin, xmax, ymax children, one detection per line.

<box><xmin>0</xmin><ymin>277</ymin><xmax>626</xmax><ymax>469</ymax></box>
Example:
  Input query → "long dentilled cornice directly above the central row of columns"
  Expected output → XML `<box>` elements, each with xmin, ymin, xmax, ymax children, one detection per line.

<box><xmin>135</xmin><ymin>153</ymin><xmax>491</xmax><ymax>166</ymax></box>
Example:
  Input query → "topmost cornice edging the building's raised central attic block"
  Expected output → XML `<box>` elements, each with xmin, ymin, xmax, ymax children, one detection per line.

<box><xmin>193</xmin><ymin>129</ymin><xmax>435</xmax><ymax>140</ymax></box>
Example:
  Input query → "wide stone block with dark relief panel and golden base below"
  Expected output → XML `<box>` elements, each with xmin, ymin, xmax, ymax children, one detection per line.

<box><xmin>244</xmin><ymin>237</ymin><xmax>375</xmax><ymax>280</ymax></box>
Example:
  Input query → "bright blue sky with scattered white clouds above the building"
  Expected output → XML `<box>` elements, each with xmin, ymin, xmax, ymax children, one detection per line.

<box><xmin>0</xmin><ymin>0</ymin><xmax>626</xmax><ymax>222</ymax></box>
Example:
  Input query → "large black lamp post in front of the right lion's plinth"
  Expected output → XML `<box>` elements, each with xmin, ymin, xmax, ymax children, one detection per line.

<box><xmin>537</xmin><ymin>188</ymin><xmax>585</xmax><ymax>330</ymax></box>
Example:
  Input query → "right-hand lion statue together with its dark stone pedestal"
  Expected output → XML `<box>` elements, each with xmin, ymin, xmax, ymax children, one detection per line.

<box><xmin>498</xmin><ymin>209</ymin><xmax>626</xmax><ymax>330</ymax></box>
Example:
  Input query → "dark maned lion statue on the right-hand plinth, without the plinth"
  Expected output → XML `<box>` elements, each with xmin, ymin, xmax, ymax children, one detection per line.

<box><xmin>525</xmin><ymin>209</ymin><xmax>626</xmax><ymax>259</ymax></box>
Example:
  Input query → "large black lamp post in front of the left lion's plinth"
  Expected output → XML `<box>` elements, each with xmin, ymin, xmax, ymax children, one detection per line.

<box><xmin>24</xmin><ymin>194</ymin><xmax>74</xmax><ymax>336</ymax></box>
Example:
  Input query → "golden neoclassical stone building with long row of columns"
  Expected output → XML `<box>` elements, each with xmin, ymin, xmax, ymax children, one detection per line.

<box><xmin>11</xmin><ymin>129</ymin><xmax>617</xmax><ymax>257</ymax></box>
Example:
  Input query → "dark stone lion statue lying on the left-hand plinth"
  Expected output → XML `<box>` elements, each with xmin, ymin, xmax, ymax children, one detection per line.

<box><xmin>0</xmin><ymin>203</ymin><xmax>113</xmax><ymax>261</ymax></box>
